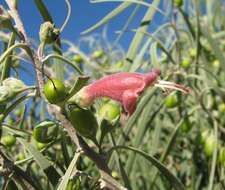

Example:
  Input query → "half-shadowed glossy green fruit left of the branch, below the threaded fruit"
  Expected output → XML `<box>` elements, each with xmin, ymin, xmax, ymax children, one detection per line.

<box><xmin>33</xmin><ymin>121</ymin><xmax>59</xmax><ymax>143</ymax></box>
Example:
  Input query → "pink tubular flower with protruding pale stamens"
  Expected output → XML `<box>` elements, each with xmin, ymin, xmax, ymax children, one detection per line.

<box><xmin>75</xmin><ymin>69</ymin><xmax>189</xmax><ymax>115</ymax></box>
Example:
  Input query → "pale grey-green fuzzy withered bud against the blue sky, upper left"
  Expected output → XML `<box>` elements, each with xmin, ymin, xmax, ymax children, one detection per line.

<box><xmin>39</xmin><ymin>22</ymin><xmax>60</xmax><ymax>44</ymax></box>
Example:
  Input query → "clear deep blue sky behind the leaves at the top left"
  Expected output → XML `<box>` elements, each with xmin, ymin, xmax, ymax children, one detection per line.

<box><xmin>0</xmin><ymin>0</ymin><xmax>164</xmax><ymax>48</ymax></box>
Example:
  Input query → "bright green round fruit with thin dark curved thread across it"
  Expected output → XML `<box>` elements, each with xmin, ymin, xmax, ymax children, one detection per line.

<box><xmin>44</xmin><ymin>79</ymin><xmax>66</xmax><ymax>104</ymax></box>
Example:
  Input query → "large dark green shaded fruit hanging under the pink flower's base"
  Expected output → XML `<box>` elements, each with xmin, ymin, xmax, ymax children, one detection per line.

<box><xmin>69</xmin><ymin>107</ymin><xmax>98</xmax><ymax>140</ymax></box>
